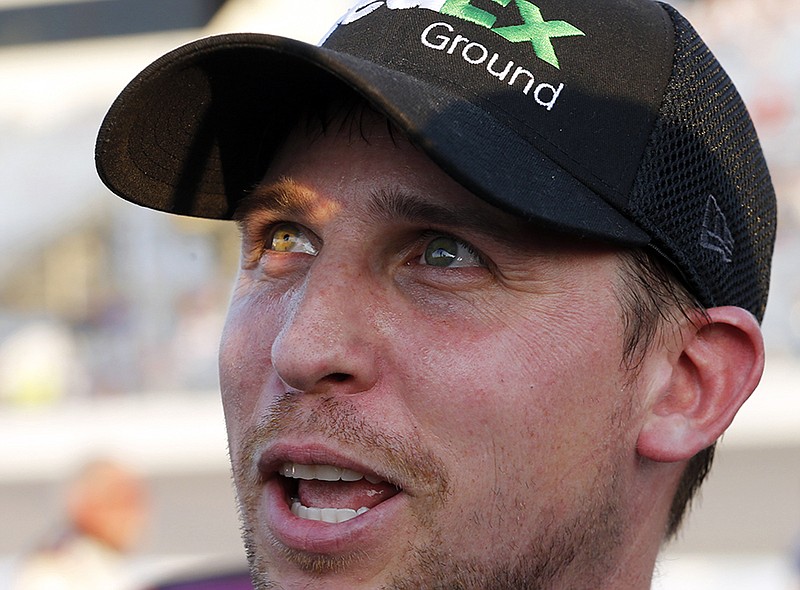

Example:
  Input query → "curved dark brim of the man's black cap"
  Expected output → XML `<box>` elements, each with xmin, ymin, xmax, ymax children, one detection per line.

<box><xmin>95</xmin><ymin>33</ymin><xmax>650</xmax><ymax>245</ymax></box>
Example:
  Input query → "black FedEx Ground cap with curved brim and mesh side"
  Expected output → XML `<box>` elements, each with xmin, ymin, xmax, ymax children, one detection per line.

<box><xmin>96</xmin><ymin>0</ymin><xmax>776</xmax><ymax>319</ymax></box>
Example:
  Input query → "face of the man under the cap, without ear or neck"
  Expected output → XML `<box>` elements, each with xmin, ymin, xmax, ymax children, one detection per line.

<box><xmin>220</xmin><ymin>113</ymin><xmax>637</xmax><ymax>589</ymax></box>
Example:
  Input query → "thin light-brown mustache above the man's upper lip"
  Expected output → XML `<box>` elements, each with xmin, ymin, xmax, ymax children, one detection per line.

<box><xmin>235</xmin><ymin>392</ymin><xmax>449</xmax><ymax>499</ymax></box>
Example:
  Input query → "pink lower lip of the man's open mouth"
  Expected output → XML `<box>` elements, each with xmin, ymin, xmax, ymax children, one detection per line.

<box><xmin>264</xmin><ymin>477</ymin><xmax>407</xmax><ymax>555</ymax></box>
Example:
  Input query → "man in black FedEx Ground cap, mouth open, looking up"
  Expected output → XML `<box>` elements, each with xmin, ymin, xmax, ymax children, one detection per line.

<box><xmin>97</xmin><ymin>0</ymin><xmax>775</xmax><ymax>590</ymax></box>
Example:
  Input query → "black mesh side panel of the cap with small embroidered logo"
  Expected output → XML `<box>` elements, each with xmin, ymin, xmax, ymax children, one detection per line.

<box><xmin>629</xmin><ymin>5</ymin><xmax>776</xmax><ymax>320</ymax></box>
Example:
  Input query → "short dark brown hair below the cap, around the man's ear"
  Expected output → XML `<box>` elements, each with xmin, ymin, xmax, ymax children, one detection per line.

<box><xmin>618</xmin><ymin>249</ymin><xmax>716</xmax><ymax>539</ymax></box>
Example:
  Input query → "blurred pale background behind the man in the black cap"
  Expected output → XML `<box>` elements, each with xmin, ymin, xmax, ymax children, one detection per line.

<box><xmin>0</xmin><ymin>0</ymin><xmax>800</xmax><ymax>590</ymax></box>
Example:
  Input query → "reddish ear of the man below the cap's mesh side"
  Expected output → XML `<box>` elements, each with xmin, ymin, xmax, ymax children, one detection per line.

<box><xmin>637</xmin><ymin>307</ymin><xmax>764</xmax><ymax>462</ymax></box>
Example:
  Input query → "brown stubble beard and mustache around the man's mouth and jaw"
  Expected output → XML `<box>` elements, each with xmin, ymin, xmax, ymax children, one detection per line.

<box><xmin>234</xmin><ymin>396</ymin><xmax>625</xmax><ymax>590</ymax></box>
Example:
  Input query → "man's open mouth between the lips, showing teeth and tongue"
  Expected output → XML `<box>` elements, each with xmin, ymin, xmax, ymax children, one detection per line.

<box><xmin>278</xmin><ymin>463</ymin><xmax>400</xmax><ymax>524</ymax></box>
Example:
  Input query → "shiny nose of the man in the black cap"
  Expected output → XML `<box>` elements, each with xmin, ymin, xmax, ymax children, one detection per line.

<box><xmin>271</xmin><ymin>264</ymin><xmax>378</xmax><ymax>394</ymax></box>
